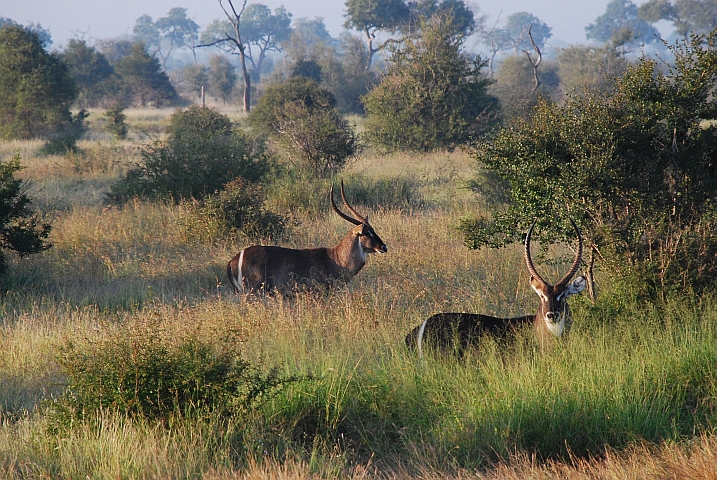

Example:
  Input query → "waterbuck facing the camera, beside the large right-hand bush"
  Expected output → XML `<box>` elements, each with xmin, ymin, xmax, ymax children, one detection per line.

<box><xmin>406</xmin><ymin>219</ymin><xmax>585</xmax><ymax>357</ymax></box>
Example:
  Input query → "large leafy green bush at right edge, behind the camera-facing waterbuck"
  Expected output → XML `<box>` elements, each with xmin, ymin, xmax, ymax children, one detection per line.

<box><xmin>464</xmin><ymin>33</ymin><xmax>717</xmax><ymax>295</ymax></box>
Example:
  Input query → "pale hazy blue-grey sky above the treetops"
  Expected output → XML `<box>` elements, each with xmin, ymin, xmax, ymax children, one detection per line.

<box><xmin>0</xmin><ymin>0</ymin><xmax>669</xmax><ymax>48</ymax></box>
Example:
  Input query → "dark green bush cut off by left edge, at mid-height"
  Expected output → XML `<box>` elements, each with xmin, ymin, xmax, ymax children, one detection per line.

<box><xmin>0</xmin><ymin>153</ymin><xmax>51</xmax><ymax>276</ymax></box>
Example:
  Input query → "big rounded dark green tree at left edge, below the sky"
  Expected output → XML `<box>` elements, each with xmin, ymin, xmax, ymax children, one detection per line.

<box><xmin>0</xmin><ymin>25</ymin><xmax>77</xmax><ymax>139</ymax></box>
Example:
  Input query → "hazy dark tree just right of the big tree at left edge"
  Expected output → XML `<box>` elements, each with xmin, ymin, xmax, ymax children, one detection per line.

<box><xmin>60</xmin><ymin>39</ymin><xmax>114</xmax><ymax>108</ymax></box>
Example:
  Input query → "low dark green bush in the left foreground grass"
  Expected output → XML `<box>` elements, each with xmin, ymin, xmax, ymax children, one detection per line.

<box><xmin>48</xmin><ymin>316</ymin><xmax>298</xmax><ymax>428</ymax></box>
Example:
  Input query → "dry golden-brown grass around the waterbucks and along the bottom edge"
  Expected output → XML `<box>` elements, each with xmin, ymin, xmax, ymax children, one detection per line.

<box><xmin>0</xmin><ymin>123</ymin><xmax>717</xmax><ymax>480</ymax></box>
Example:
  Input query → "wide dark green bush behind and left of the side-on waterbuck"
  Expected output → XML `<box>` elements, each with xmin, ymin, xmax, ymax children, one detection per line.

<box><xmin>110</xmin><ymin>106</ymin><xmax>269</xmax><ymax>201</ymax></box>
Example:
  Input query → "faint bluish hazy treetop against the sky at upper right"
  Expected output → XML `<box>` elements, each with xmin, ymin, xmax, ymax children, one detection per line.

<box><xmin>585</xmin><ymin>0</ymin><xmax>659</xmax><ymax>47</ymax></box>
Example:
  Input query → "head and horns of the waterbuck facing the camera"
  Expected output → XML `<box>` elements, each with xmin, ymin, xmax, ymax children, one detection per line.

<box><xmin>525</xmin><ymin>219</ymin><xmax>585</xmax><ymax>340</ymax></box>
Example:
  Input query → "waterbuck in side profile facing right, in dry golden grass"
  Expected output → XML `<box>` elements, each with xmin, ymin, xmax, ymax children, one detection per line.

<box><xmin>227</xmin><ymin>181</ymin><xmax>388</xmax><ymax>293</ymax></box>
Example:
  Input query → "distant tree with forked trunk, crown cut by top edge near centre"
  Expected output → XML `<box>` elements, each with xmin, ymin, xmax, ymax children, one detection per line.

<box><xmin>344</xmin><ymin>0</ymin><xmax>411</xmax><ymax>70</ymax></box>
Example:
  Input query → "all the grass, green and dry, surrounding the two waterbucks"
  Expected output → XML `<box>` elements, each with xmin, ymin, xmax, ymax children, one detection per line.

<box><xmin>0</xmin><ymin>125</ymin><xmax>717</xmax><ymax>479</ymax></box>
